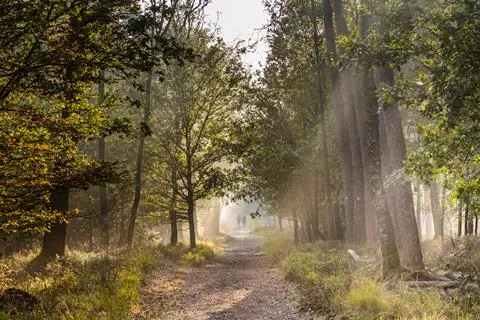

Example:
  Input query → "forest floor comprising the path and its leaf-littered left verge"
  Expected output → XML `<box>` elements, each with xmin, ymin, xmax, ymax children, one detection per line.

<box><xmin>140</xmin><ymin>232</ymin><xmax>305</xmax><ymax>320</ymax></box>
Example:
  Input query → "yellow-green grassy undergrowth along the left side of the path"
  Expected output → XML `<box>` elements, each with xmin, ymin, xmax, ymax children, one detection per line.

<box><xmin>0</xmin><ymin>243</ymin><xmax>214</xmax><ymax>320</ymax></box>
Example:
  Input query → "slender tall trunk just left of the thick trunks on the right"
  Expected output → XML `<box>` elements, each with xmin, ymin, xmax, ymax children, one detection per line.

<box><xmin>311</xmin><ymin>0</ymin><xmax>335</xmax><ymax>240</ymax></box>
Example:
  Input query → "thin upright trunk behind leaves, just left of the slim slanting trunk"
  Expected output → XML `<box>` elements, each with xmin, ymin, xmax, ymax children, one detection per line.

<box><xmin>98</xmin><ymin>70</ymin><xmax>110</xmax><ymax>250</ymax></box>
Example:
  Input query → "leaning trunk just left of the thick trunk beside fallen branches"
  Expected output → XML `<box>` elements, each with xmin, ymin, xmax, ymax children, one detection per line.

<box><xmin>360</xmin><ymin>15</ymin><xmax>401</xmax><ymax>277</ymax></box>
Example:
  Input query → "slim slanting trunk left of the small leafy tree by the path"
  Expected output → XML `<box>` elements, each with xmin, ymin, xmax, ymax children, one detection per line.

<box><xmin>127</xmin><ymin>69</ymin><xmax>153</xmax><ymax>247</ymax></box>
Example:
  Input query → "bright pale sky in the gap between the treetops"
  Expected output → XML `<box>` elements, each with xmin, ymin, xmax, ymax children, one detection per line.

<box><xmin>206</xmin><ymin>0</ymin><xmax>268</xmax><ymax>69</ymax></box>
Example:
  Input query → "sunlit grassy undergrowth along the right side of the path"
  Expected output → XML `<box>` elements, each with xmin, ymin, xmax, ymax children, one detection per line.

<box><xmin>263</xmin><ymin>235</ymin><xmax>480</xmax><ymax>320</ymax></box>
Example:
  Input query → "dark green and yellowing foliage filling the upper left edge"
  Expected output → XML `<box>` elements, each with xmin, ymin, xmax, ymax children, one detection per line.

<box><xmin>0</xmin><ymin>0</ymin><xmax>135</xmax><ymax>236</ymax></box>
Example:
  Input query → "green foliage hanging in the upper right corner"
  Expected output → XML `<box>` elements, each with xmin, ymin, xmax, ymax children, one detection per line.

<box><xmin>341</xmin><ymin>0</ymin><xmax>480</xmax><ymax>205</ymax></box>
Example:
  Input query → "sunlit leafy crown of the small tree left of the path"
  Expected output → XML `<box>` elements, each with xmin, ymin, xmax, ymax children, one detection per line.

<box><xmin>146</xmin><ymin>26</ymin><xmax>250</xmax><ymax>219</ymax></box>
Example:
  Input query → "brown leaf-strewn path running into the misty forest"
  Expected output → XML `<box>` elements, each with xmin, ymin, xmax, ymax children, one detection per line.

<box><xmin>161</xmin><ymin>232</ymin><xmax>304</xmax><ymax>320</ymax></box>
